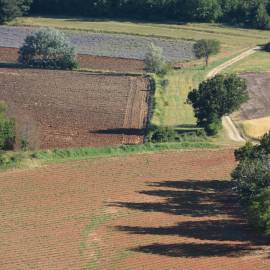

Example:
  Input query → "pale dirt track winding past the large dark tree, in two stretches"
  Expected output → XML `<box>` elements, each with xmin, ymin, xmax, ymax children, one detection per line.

<box><xmin>207</xmin><ymin>47</ymin><xmax>260</xmax><ymax>143</ymax></box>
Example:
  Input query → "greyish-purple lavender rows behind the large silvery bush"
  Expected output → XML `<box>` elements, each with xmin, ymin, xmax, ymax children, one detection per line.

<box><xmin>0</xmin><ymin>26</ymin><xmax>194</xmax><ymax>62</ymax></box>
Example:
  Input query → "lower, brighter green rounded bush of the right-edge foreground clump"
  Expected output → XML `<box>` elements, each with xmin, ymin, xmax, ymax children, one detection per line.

<box><xmin>248</xmin><ymin>188</ymin><xmax>270</xmax><ymax>236</ymax></box>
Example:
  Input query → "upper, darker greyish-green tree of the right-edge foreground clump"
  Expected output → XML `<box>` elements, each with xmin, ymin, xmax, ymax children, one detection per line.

<box><xmin>232</xmin><ymin>133</ymin><xmax>270</xmax><ymax>203</ymax></box>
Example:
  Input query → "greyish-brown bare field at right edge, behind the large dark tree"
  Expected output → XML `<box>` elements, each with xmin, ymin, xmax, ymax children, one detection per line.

<box><xmin>236</xmin><ymin>73</ymin><xmax>270</xmax><ymax>120</ymax></box>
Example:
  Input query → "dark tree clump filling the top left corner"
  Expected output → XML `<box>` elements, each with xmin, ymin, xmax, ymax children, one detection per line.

<box><xmin>0</xmin><ymin>0</ymin><xmax>32</xmax><ymax>23</ymax></box>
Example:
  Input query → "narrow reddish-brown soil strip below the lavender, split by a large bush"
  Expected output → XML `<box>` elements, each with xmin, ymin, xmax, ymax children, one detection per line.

<box><xmin>0</xmin><ymin>47</ymin><xmax>144</xmax><ymax>72</ymax></box>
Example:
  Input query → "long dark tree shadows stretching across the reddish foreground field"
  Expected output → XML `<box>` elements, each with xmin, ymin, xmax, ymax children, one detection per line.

<box><xmin>109</xmin><ymin>180</ymin><xmax>269</xmax><ymax>257</ymax></box>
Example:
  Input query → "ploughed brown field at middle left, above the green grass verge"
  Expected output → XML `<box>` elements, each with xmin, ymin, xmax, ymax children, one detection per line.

<box><xmin>0</xmin><ymin>68</ymin><xmax>150</xmax><ymax>149</ymax></box>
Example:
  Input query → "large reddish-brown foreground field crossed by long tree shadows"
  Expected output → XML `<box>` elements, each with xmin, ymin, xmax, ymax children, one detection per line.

<box><xmin>0</xmin><ymin>150</ymin><xmax>270</xmax><ymax>270</ymax></box>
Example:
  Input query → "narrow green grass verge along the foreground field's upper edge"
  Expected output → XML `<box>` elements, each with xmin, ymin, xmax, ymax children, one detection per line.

<box><xmin>0</xmin><ymin>142</ymin><xmax>219</xmax><ymax>170</ymax></box>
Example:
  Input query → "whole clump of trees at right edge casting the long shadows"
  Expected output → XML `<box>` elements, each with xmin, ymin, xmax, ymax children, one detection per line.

<box><xmin>232</xmin><ymin>132</ymin><xmax>270</xmax><ymax>236</ymax></box>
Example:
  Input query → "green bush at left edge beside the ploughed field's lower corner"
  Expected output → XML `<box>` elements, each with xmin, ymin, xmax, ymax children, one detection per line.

<box><xmin>0</xmin><ymin>102</ymin><xmax>16</xmax><ymax>150</ymax></box>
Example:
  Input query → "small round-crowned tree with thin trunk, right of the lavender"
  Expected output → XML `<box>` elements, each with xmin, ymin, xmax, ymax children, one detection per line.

<box><xmin>193</xmin><ymin>39</ymin><xmax>220</xmax><ymax>66</ymax></box>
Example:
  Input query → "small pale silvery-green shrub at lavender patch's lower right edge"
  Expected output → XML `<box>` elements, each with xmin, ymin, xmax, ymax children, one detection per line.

<box><xmin>144</xmin><ymin>43</ymin><xmax>169</xmax><ymax>76</ymax></box>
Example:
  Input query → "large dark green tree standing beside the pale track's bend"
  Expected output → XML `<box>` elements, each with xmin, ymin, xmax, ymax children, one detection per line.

<box><xmin>187</xmin><ymin>75</ymin><xmax>248</xmax><ymax>135</ymax></box>
